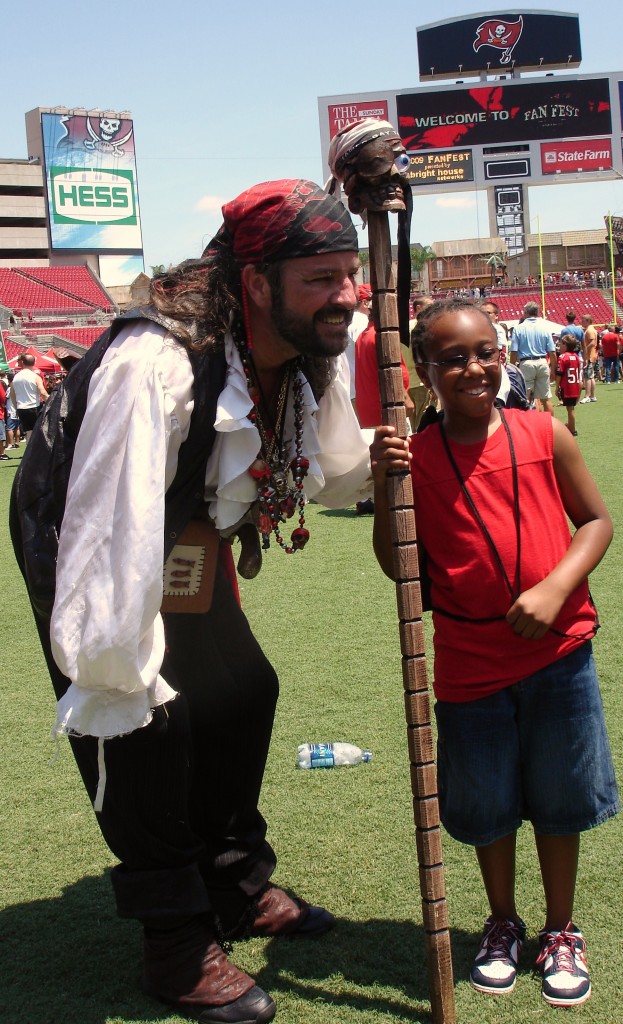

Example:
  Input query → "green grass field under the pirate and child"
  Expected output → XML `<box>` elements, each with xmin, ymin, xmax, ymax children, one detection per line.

<box><xmin>0</xmin><ymin>385</ymin><xmax>623</xmax><ymax>1024</ymax></box>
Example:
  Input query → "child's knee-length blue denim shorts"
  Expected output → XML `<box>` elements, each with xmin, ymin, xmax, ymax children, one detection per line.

<box><xmin>434</xmin><ymin>642</ymin><xmax>620</xmax><ymax>846</ymax></box>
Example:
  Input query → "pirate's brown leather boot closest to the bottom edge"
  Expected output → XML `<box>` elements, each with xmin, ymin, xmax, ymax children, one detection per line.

<box><xmin>143</xmin><ymin>916</ymin><xmax>276</xmax><ymax>1024</ymax></box>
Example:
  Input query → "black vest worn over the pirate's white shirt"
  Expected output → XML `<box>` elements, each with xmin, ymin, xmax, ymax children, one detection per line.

<box><xmin>9</xmin><ymin>306</ymin><xmax>226</xmax><ymax>618</ymax></box>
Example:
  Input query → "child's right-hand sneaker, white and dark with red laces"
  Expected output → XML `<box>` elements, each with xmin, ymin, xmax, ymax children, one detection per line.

<box><xmin>537</xmin><ymin>921</ymin><xmax>590</xmax><ymax>1007</ymax></box>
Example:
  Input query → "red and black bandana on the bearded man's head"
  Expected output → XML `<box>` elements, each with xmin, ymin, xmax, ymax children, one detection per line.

<box><xmin>204</xmin><ymin>178</ymin><xmax>359</xmax><ymax>264</ymax></box>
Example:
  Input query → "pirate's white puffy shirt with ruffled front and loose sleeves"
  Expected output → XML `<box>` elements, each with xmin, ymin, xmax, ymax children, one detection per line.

<box><xmin>50</xmin><ymin>322</ymin><xmax>370</xmax><ymax>738</ymax></box>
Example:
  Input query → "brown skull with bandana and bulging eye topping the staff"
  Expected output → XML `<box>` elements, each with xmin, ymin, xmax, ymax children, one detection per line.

<box><xmin>329</xmin><ymin>118</ymin><xmax>410</xmax><ymax>214</ymax></box>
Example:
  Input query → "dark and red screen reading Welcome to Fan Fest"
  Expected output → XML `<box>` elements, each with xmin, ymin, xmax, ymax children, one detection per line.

<box><xmin>396</xmin><ymin>77</ymin><xmax>612</xmax><ymax>153</ymax></box>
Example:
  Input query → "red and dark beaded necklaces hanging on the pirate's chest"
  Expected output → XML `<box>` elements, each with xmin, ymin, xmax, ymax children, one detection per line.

<box><xmin>236</xmin><ymin>323</ymin><xmax>309</xmax><ymax>555</ymax></box>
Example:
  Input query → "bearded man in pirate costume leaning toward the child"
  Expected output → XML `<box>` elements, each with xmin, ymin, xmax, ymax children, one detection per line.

<box><xmin>12</xmin><ymin>180</ymin><xmax>369</xmax><ymax>1024</ymax></box>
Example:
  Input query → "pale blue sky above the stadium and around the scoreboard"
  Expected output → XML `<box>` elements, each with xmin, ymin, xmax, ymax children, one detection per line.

<box><xmin>0</xmin><ymin>0</ymin><xmax>623</xmax><ymax>271</ymax></box>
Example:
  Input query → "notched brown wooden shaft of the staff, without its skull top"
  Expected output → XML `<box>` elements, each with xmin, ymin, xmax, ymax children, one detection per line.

<box><xmin>368</xmin><ymin>211</ymin><xmax>456</xmax><ymax>1024</ymax></box>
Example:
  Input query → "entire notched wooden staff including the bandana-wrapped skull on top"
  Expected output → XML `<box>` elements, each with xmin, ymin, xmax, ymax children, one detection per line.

<box><xmin>329</xmin><ymin>118</ymin><xmax>456</xmax><ymax>1024</ymax></box>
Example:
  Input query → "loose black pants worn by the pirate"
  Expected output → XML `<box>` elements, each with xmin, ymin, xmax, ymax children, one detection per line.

<box><xmin>31</xmin><ymin>569</ymin><xmax>279</xmax><ymax>929</ymax></box>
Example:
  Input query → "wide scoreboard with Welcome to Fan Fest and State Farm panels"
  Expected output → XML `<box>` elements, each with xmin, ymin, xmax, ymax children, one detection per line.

<box><xmin>319</xmin><ymin>72</ymin><xmax>623</xmax><ymax>194</ymax></box>
